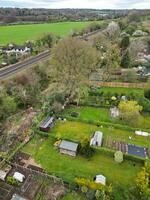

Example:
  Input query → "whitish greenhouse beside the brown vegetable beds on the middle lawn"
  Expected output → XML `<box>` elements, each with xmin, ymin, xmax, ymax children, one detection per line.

<box><xmin>90</xmin><ymin>131</ymin><xmax>103</xmax><ymax>146</ymax></box>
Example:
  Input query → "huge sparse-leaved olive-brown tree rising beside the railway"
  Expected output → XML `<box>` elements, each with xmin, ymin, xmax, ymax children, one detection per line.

<box><xmin>51</xmin><ymin>37</ymin><xmax>98</xmax><ymax>100</ymax></box>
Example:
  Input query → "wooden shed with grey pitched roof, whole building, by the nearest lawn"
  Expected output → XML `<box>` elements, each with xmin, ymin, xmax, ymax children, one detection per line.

<box><xmin>59</xmin><ymin>140</ymin><xmax>78</xmax><ymax>157</ymax></box>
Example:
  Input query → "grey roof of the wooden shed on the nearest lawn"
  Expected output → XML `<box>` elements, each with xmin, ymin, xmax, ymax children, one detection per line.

<box><xmin>59</xmin><ymin>140</ymin><xmax>78</xmax><ymax>152</ymax></box>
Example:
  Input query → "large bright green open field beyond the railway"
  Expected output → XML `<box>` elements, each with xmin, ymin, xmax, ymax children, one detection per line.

<box><xmin>0</xmin><ymin>22</ymin><xmax>91</xmax><ymax>45</ymax></box>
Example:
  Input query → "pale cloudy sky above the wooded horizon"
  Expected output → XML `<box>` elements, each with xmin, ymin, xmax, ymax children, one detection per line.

<box><xmin>0</xmin><ymin>0</ymin><xmax>150</xmax><ymax>9</ymax></box>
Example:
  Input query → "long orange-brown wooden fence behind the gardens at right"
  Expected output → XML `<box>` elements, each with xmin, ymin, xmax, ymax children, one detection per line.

<box><xmin>90</xmin><ymin>81</ymin><xmax>150</xmax><ymax>89</ymax></box>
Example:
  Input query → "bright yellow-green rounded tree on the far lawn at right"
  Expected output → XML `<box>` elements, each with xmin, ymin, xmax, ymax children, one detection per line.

<box><xmin>119</xmin><ymin>101</ymin><xmax>142</xmax><ymax>125</ymax></box>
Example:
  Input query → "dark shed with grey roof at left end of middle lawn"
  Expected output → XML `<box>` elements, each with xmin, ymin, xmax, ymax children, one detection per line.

<box><xmin>39</xmin><ymin>117</ymin><xmax>55</xmax><ymax>132</ymax></box>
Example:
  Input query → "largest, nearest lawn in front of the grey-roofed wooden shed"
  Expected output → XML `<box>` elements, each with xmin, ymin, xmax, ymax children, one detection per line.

<box><xmin>22</xmin><ymin>136</ymin><xmax>142</xmax><ymax>188</ymax></box>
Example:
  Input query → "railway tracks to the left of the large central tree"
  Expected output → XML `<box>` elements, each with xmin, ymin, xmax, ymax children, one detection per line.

<box><xmin>0</xmin><ymin>51</ymin><xmax>50</xmax><ymax>79</ymax></box>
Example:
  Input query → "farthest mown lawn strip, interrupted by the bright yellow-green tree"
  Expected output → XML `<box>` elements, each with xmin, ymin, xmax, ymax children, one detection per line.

<box><xmin>63</xmin><ymin>106</ymin><xmax>150</xmax><ymax>129</ymax></box>
